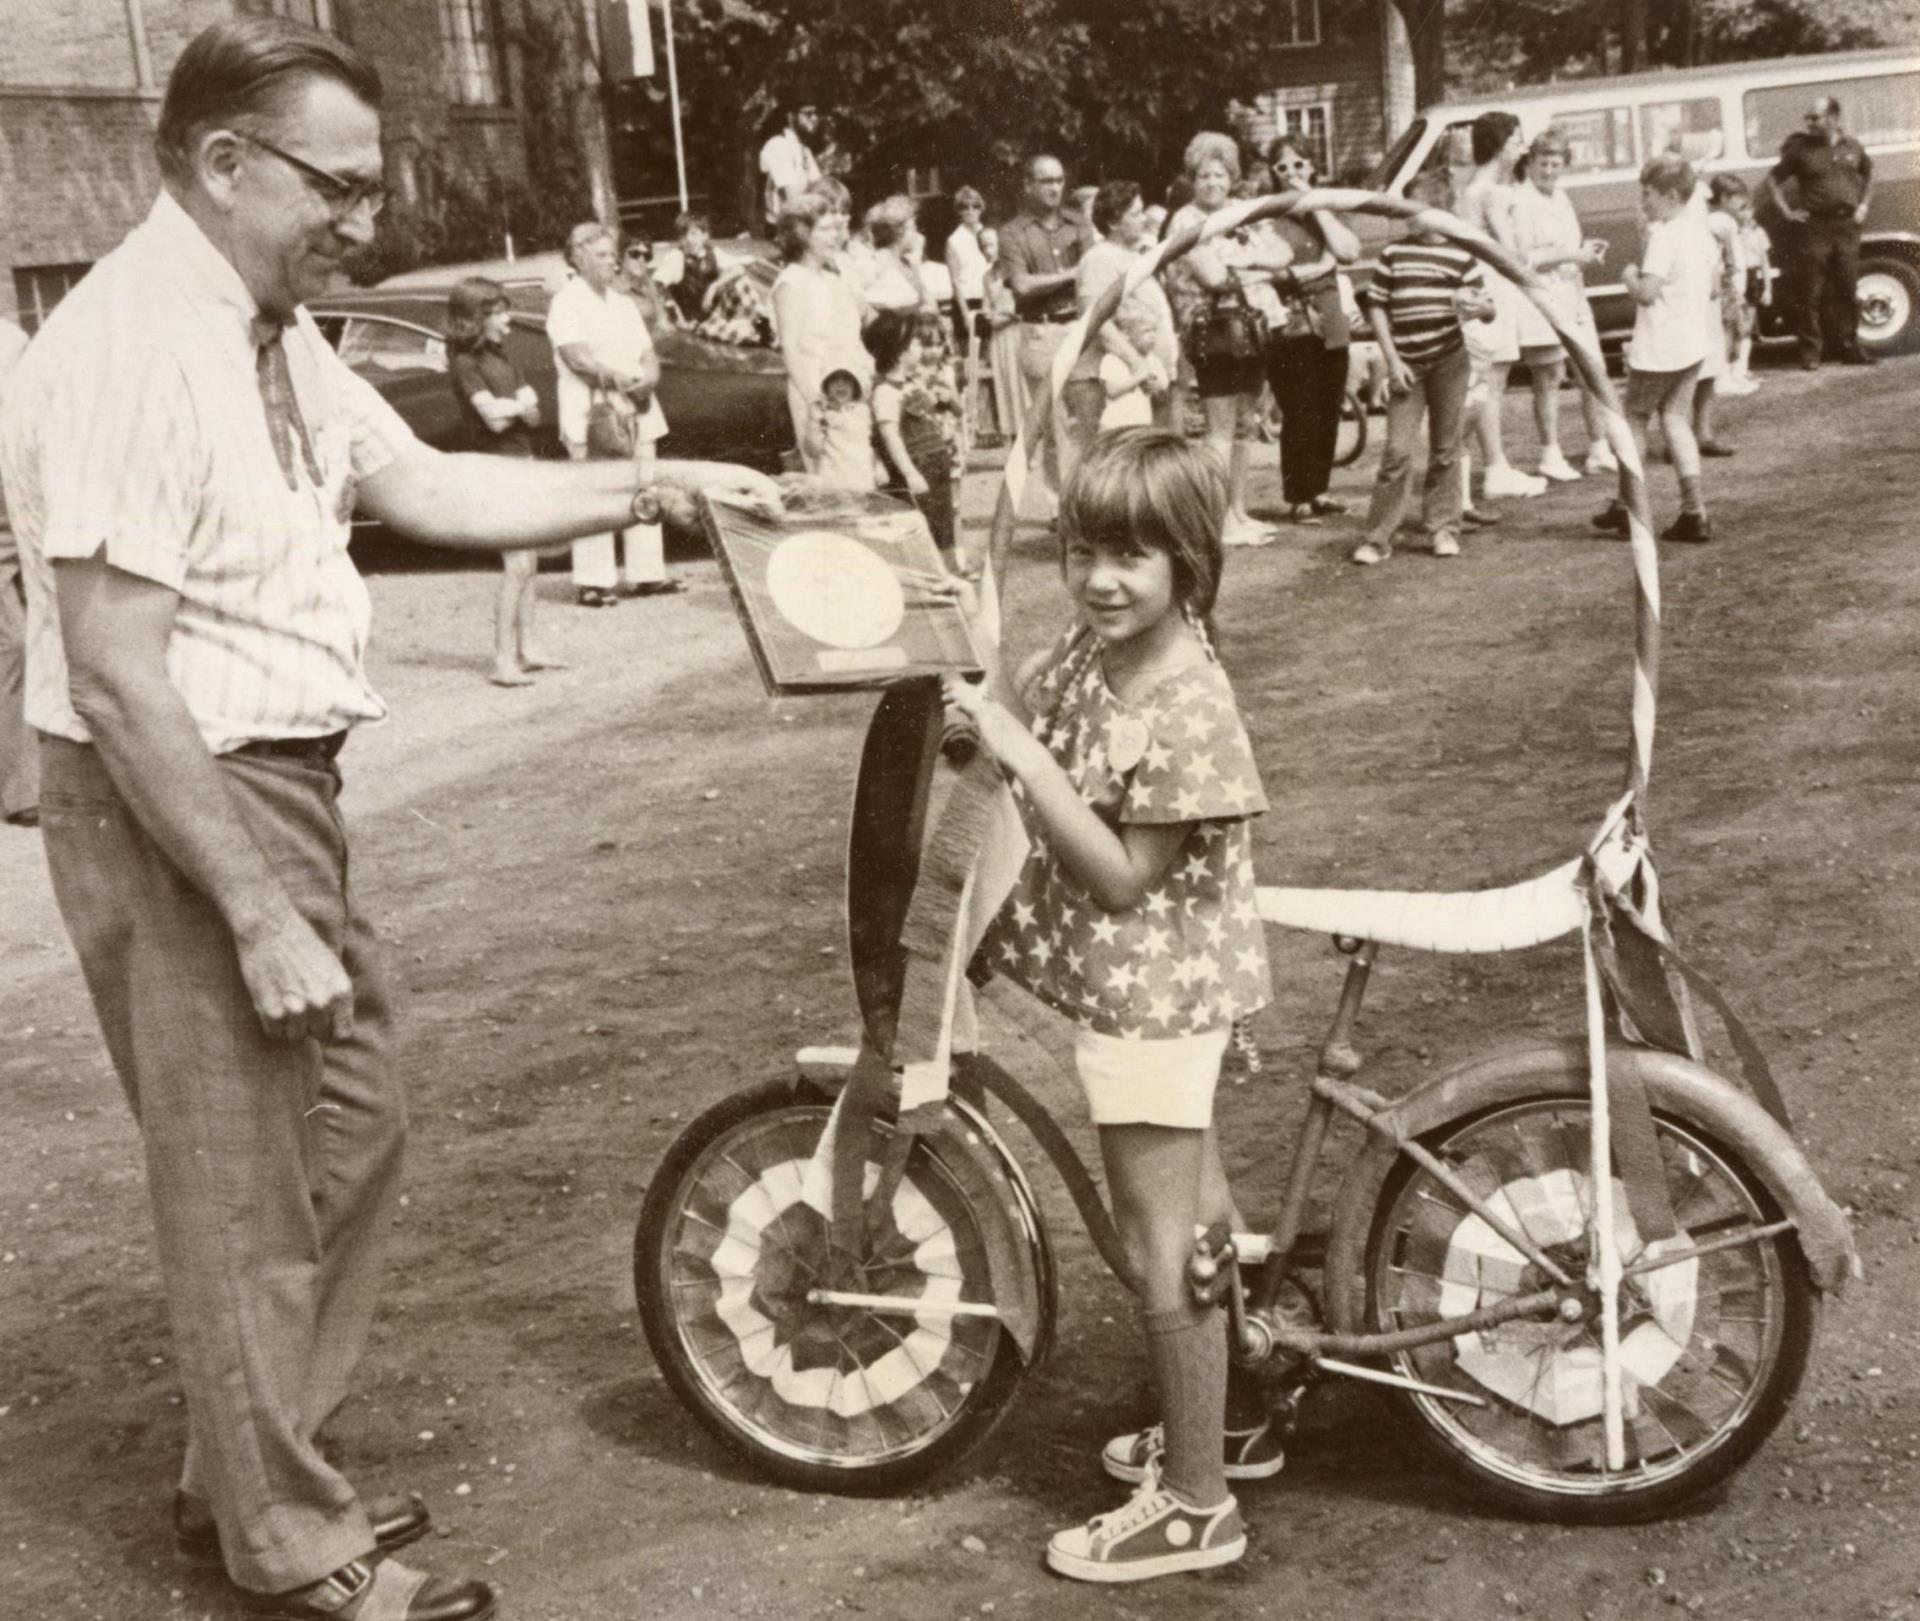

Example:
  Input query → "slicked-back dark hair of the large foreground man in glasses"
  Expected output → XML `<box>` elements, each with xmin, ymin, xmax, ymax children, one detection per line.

<box><xmin>154</xmin><ymin>17</ymin><xmax>380</xmax><ymax>181</ymax></box>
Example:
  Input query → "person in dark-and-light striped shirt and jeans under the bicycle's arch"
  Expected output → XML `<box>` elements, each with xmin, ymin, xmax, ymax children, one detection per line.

<box><xmin>1348</xmin><ymin>169</ymin><xmax>1494</xmax><ymax>565</ymax></box>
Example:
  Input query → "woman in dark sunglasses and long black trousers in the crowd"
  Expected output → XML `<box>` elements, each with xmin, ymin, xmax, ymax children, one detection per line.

<box><xmin>1267</xmin><ymin>134</ymin><xmax>1359</xmax><ymax>524</ymax></box>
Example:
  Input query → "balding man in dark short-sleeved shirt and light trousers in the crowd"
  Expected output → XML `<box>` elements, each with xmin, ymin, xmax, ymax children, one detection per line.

<box><xmin>1000</xmin><ymin>152</ymin><xmax>1100</xmax><ymax>514</ymax></box>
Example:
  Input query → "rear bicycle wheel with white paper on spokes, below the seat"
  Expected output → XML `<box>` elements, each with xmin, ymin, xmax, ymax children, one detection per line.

<box><xmin>1367</xmin><ymin>1099</ymin><xmax>1818</xmax><ymax>1525</ymax></box>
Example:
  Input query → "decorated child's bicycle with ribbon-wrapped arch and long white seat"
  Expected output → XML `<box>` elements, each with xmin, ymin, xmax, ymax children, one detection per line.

<box><xmin>634</xmin><ymin>192</ymin><xmax>1857</xmax><ymax>1523</ymax></box>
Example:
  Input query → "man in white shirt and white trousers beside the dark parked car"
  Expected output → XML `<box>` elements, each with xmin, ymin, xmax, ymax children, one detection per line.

<box><xmin>547</xmin><ymin>219</ymin><xmax>680</xmax><ymax>607</ymax></box>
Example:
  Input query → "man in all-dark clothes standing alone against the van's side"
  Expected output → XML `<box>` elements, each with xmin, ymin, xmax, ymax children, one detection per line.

<box><xmin>1764</xmin><ymin>96</ymin><xmax>1874</xmax><ymax>371</ymax></box>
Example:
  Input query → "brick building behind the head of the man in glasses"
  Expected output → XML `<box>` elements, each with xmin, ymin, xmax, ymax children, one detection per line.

<box><xmin>0</xmin><ymin>0</ymin><xmax>557</xmax><ymax>330</ymax></box>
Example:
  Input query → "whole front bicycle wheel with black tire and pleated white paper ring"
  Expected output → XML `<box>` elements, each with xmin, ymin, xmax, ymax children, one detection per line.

<box><xmin>634</xmin><ymin>1083</ymin><xmax>1050</xmax><ymax>1492</ymax></box>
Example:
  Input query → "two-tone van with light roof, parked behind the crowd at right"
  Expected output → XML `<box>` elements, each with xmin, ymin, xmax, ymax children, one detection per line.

<box><xmin>1354</xmin><ymin>48</ymin><xmax>1920</xmax><ymax>353</ymax></box>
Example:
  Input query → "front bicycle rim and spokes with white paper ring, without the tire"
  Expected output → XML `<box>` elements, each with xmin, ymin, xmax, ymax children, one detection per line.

<box><xmin>659</xmin><ymin>1104</ymin><xmax>1006</xmax><ymax>1469</ymax></box>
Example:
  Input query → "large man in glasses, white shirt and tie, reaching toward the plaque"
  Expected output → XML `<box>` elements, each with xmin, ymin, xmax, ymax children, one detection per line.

<box><xmin>0</xmin><ymin>17</ymin><xmax>770</xmax><ymax>1621</ymax></box>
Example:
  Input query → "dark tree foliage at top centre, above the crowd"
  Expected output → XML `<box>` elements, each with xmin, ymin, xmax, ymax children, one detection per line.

<box><xmin>616</xmin><ymin>0</ymin><xmax>1375</xmax><ymax>224</ymax></box>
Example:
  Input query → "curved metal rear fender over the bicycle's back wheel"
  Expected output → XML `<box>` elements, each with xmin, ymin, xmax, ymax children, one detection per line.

<box><xmin>1325</xmin><ymin>1041</ymin><xmax>1859</xmax><ymax>1333</ymax></box>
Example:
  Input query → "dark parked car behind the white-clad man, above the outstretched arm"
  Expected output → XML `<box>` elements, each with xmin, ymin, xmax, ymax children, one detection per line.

<box><xmin>307</xmin><ymin>272</ymin><xmax>793</xmax><ymax>471</ymax></box>
